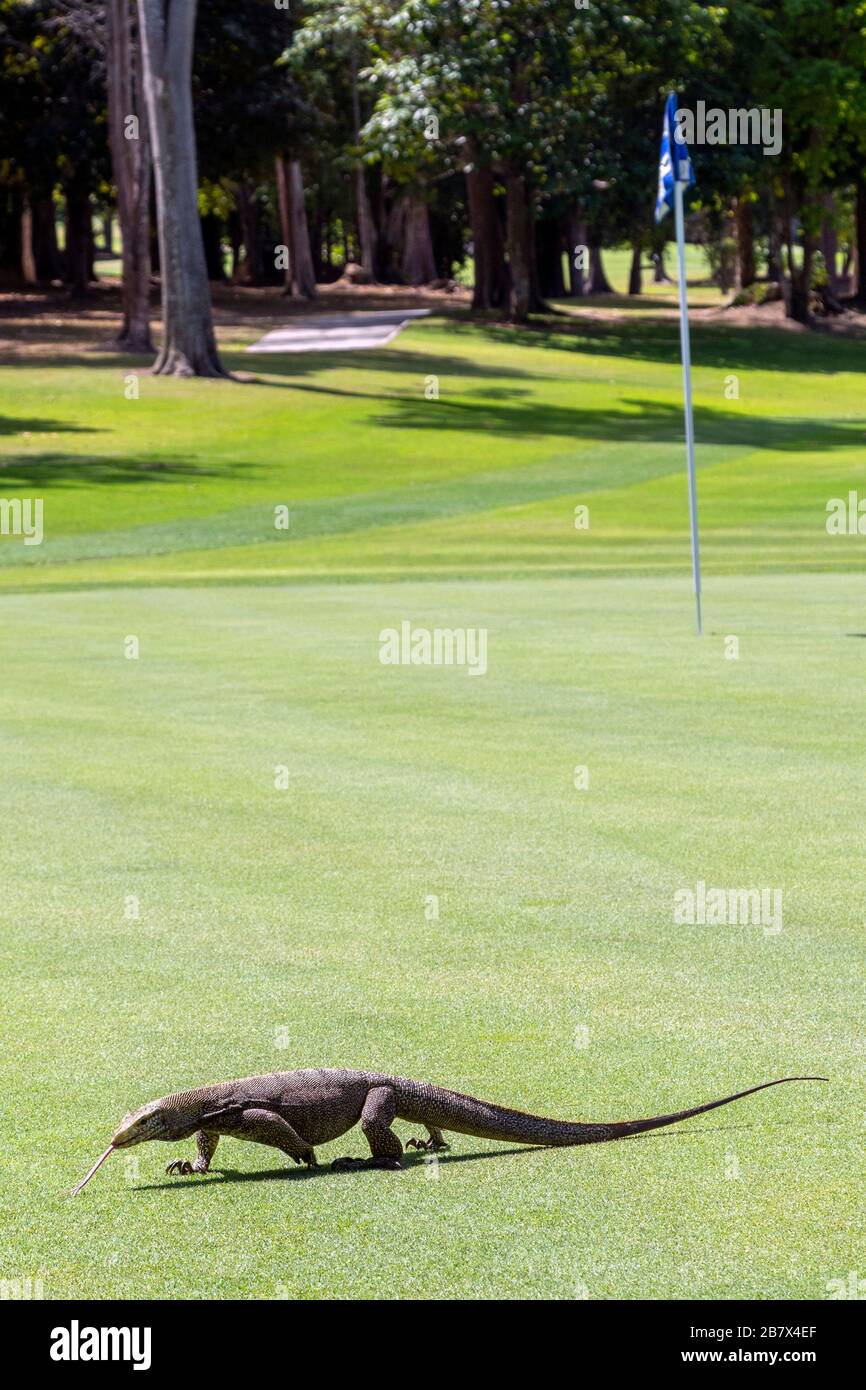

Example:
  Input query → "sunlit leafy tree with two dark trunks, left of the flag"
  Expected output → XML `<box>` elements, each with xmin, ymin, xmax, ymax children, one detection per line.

<box><xmin>355</xmin><ymin>0</ymin><xmax>581</xmax><ymax>321</ymax></box>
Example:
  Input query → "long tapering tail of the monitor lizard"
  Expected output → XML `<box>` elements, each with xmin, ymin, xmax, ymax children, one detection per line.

<box><xmin>395</xmin><ymin>1076</ymin><xmax>828</xmax><ymax>1147</ymax></box>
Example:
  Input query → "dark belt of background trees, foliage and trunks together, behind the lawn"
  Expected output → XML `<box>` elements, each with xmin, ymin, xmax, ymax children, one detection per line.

<box><xmin>0</xmin><ymin>0</ymin><xmax>866</xmax><ymax>336</ymax></box>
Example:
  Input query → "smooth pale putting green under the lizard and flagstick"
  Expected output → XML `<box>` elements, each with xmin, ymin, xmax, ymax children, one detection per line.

<box><xmin>0</xmin><ymin>575</ymin><xmax>866</xmax><ymax>1298</ymax></box>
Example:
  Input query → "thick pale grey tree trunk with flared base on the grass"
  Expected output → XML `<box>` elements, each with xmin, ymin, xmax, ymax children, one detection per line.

<box><xmin>138</xmin><ymin>0</ymin><xmax>225</xmax><ymax>377</ymax></box>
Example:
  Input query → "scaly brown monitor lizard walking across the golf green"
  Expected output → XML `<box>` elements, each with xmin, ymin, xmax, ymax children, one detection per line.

<box><xmin>94</xmin><ymin>1069</ymin><xmax>826</xmax><ymax>1191</ymax></box>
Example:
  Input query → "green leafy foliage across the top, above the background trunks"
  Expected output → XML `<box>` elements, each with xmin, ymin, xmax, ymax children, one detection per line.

<box><xmin>6</xmin><ymin>0</ymin><xmax>866</xmax><ymax>305</ymax></box>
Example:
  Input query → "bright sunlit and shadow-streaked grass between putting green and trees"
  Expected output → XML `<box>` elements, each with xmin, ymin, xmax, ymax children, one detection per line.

<box><xmin>0</xmin><ymin>312</ymin><xmax>866</xmax><ymax>588</ymax></box>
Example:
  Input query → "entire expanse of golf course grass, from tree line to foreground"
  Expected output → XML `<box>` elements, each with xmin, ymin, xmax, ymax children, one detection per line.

<box><xmin>0</xmin><ymin>318</ymin><xmax>866</xmax><ymax>1300</ymax></box>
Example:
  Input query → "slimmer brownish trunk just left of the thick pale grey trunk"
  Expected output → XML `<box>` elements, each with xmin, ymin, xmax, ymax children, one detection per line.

<box><xmin>106</xmin><ymin>0</ymin><xmax>153</xmax><ymax>353</ymax></box>
